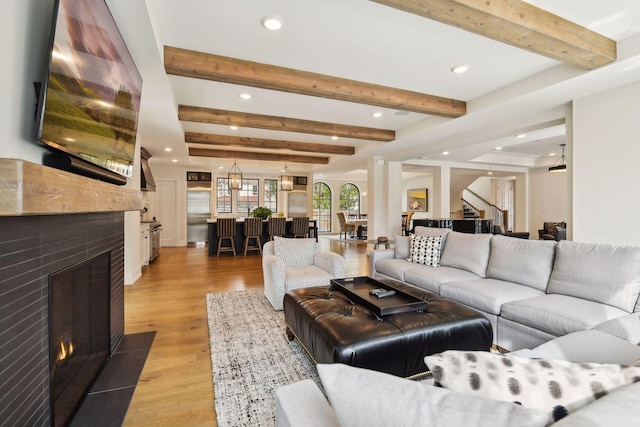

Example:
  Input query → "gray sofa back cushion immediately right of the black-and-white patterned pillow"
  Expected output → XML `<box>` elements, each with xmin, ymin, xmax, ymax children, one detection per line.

<box><xmin>440</xmin><ymin>231</ymin><xmax>492</xmax><ymax>277</ymax></box>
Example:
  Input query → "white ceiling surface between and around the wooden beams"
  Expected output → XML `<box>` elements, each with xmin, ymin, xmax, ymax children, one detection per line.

<box><xmin>107</xmin><ymin>0</ymin><xmax>640</xmax><ymax>180</ymax></box>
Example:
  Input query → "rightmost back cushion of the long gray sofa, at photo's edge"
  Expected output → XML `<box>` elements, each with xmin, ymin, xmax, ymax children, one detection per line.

<box><xmin>547</xmin><ymin>240</ymin><xmax>640</xmax><ymax>313</ymax></box>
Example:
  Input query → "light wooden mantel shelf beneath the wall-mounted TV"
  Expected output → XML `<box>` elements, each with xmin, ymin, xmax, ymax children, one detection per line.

<box><xmin>0</xmin><ymin>159</ymin><xmax>142</xmax><ymax>216</ymax></box>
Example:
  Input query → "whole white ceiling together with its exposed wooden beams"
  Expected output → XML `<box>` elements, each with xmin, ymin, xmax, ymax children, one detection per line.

<box><xmin>109</xmin><ymin>0</ymin><xmax>640</xmax><ymax>179</ymax></box>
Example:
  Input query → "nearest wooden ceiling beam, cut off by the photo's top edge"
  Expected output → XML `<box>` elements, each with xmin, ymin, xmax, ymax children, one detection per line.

<box><xmin>371</xmin><ymin>0</ymin><xmax>617</xmax><ymax>70</ymax></box>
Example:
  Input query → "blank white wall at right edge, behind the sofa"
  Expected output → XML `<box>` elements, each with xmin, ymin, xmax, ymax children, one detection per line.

<box><xmin>572</xmin><ymin>83</ymin><xmax>640</xmax><ymax>245</ymax></box>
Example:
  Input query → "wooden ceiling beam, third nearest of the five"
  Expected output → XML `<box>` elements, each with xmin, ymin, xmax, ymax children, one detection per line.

<box><xmin>178</xmin><ymin>105</ymin><xmax>396</xmax><ymax>142</ymax></box>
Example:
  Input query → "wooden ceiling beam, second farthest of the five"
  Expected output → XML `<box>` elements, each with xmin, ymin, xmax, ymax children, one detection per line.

<box><xmin>184</xmin><ymin>132</ymin><xmax>356</xmax><ymax>155</ymax></box>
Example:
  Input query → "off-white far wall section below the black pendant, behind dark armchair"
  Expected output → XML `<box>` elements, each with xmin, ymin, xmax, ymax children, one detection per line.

<box><xmin>527</xmin><ymin>167</ymin><xmax>571</xmax><ymax>239</ymax></box>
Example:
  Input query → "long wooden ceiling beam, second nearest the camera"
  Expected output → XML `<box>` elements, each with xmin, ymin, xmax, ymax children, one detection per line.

<box><xmin>164</xmin><ymin>46</ymin><xmax>467</xmax><ymax>117</ymax></box>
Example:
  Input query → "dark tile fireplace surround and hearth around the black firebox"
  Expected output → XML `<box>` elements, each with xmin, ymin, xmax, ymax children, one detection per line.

<box><xmin>0</xmin><ymin>212</ymin><xmax>153</xmax><ymax>426</ymax></box>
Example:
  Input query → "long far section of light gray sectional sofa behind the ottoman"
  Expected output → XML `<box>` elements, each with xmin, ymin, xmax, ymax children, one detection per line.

<box><xmin>369</xmin><ymin>227</ymin><xmax>640</xmax><ymax>351</ymax></box>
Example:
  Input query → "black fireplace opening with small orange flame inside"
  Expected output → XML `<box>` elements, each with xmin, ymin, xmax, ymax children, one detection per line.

<box><xmin>49</xmin><ymin>251</ymin><xmax>111</xmax><ymax>427</ymax></box>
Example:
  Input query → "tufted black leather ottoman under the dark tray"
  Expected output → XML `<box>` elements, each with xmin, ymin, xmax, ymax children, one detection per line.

<box><xmin>283</xmin><ymin>281</ymin><xmax>493</xmax><ymax>377</ymax></box>
